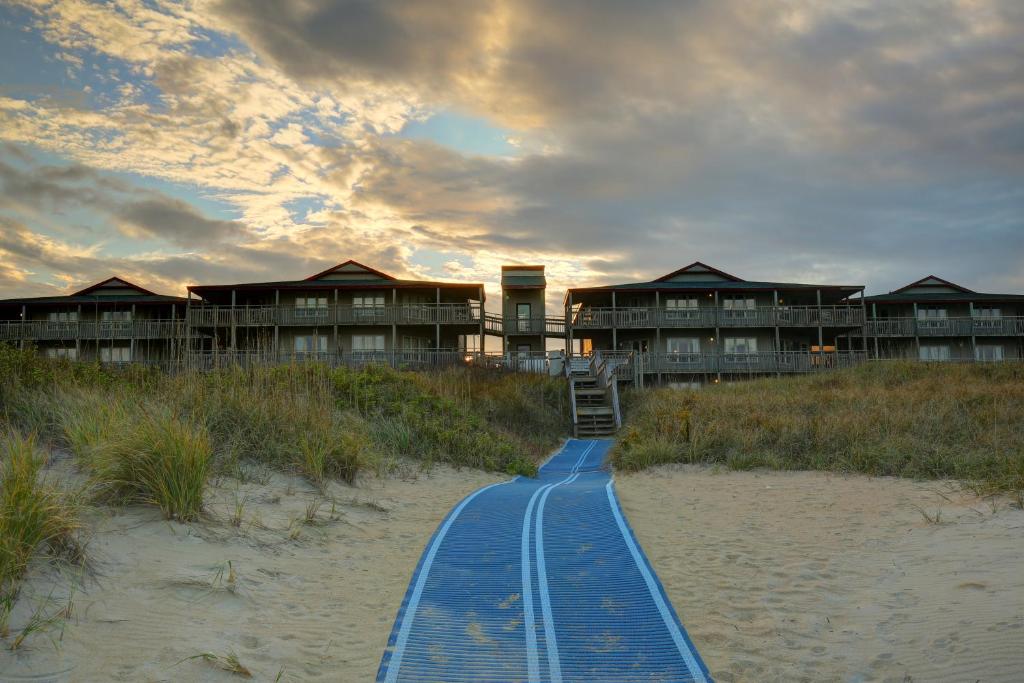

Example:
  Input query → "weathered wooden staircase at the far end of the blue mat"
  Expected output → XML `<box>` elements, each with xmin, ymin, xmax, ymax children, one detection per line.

<box><xmin>565</xmin><ymin>353</ymin><xmax>622</xmax><ymax>438</ymax></box>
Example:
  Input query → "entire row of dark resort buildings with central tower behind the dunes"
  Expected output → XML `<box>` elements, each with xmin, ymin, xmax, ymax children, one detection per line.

<box><xmin>0</xmin><ymin>260</ymin><xmax>1024</xmax><ymax>378</ymax></box>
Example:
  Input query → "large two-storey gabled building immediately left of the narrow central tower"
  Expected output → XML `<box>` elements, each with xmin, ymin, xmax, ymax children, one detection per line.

<box><xmin>186</xmin><ymin>260</ymin><xmax>484</xmax><ymax>366</ymax></box>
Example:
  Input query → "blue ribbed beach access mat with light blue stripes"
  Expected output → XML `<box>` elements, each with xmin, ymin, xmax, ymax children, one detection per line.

<box><xmin>377</xmin><ymin>439</ymin><xmax>711</xmax><ymax>683</ymax></box>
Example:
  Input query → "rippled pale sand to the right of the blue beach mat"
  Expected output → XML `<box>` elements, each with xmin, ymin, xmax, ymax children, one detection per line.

<box><xmin>616</xmin><ymin>466</ymin><xmax>1024</xmax><ymax>683</ymax></box>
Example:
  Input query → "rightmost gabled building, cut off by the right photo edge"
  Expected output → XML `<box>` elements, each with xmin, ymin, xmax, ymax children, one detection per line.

<box><xmin>865</xmin><ymin>275</ymin><xmax>1024</xmax><ymax>361</ymax></box>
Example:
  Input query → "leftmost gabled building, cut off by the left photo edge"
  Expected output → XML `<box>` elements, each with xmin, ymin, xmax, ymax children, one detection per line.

<box><xmin>0</xmin><ymin>278</ymin><xmax>186</xmax><ymax>364</ymax></box>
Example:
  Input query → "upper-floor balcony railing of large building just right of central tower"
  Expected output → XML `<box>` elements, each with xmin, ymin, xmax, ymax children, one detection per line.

<box><xmin>572</xmin><ymin>306</ymin><xmax>864</xmax><ymax>330</ymax></box>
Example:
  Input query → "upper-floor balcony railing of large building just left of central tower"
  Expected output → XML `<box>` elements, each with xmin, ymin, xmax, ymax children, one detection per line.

<box><xmin>187</xmin><ymin>303</ymin><xmax>480</xmax><ymax>328</ymax></box>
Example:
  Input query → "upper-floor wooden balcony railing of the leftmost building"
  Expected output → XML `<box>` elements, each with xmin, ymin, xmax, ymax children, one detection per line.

<box><xmin>0</xmin><ymin>319</ymin><xmax>184</xmax><ymax>341</ymax></box>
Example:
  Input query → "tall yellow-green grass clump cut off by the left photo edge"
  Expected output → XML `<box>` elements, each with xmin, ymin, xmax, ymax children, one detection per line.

<box><xmin>0</xmin><ymin>432</ymin><xmax>82</xmax><ymax>631</ymax></box>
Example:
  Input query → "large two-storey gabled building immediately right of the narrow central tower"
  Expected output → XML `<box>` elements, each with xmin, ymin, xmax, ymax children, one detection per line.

<box><xmin>565</xmin><ymin>262</ymin><xmax>865</xmax><ymax>382</ymax></box>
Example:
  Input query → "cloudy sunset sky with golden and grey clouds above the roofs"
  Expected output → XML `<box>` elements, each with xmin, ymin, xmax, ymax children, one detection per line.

<box><xmin>0</xmin><ymin>0</ymin><xmax>1024</xmax><ymax>299</ymax></box>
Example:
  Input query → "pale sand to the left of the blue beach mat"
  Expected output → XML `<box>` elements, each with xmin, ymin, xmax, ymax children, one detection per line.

<box><xmin>0</xmin><ymin>467</ymin><xmax>508</xmax><ymax>682</ymax></box>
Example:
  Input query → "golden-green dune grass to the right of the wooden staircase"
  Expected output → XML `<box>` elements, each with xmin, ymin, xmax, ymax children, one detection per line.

<box><xmin>612</xmin><ymin>362</ymin><xmax>1024</xmax><ymax>495</ymax></box>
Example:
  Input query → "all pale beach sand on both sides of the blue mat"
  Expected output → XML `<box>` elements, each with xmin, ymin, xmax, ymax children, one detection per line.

<box><xmin>0</xmin><ymin>466</ymin><xmax>1024</xmax><ymax>683</ymax></box>
